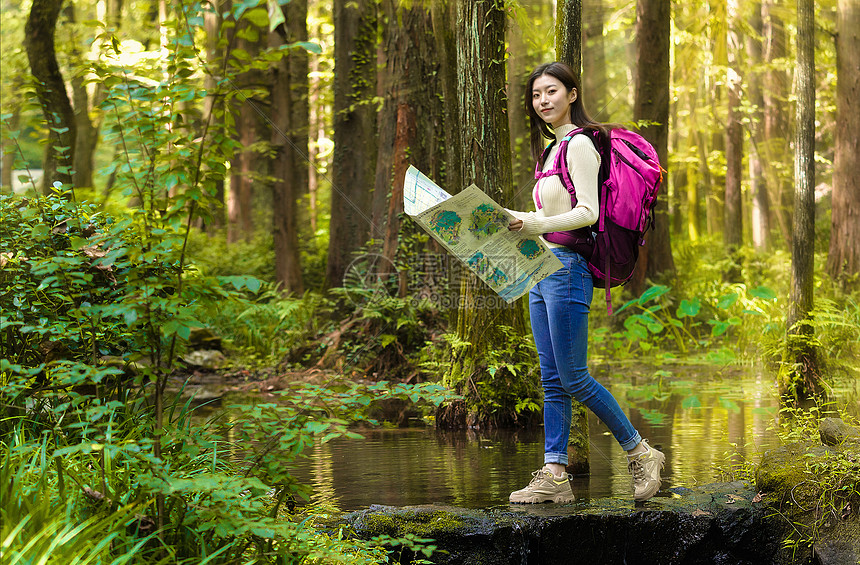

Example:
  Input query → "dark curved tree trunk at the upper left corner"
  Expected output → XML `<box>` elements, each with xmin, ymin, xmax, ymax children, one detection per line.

<box><xmin>24</xmin><ymin>0</ymin><xmax>77</xmax><ymax>192</ymax></box>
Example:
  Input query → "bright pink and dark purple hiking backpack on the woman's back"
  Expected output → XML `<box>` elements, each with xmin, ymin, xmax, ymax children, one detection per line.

<box><xmin>535</xmin><ymin>128</ymin><xmax>664</xmax><ymax>314</ymax></box>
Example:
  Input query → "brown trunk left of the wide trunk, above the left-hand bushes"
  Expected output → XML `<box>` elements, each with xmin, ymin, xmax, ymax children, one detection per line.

<box><xmin>270</xmin><ymin>0</ymin><xmax>308</xmax><ymax>294</ymax></box>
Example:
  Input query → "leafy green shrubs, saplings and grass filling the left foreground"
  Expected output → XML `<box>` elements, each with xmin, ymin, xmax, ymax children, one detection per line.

<box><xmin>0</xmin><ymin>1</ymin><xmax>446</xmax><ymax>563</ymax></box>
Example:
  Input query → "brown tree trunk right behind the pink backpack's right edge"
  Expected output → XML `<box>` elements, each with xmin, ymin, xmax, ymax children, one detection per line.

<box><xmin>631</xmin><ymin>0</ymin><xmax>675</xmax><ymax>294</ymax></box>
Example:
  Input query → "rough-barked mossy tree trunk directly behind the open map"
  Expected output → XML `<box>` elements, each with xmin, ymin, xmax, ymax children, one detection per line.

<box><xmin>445</xmin><ymin>0</ymin><xmax>527</xmax><ymax>424</ymax></box>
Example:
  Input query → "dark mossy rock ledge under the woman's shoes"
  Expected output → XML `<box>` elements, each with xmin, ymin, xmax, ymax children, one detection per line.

<box><xmin>346</xmin><ymin>482</ymin><xmax>805</xmax><ymax>565</ymax></box>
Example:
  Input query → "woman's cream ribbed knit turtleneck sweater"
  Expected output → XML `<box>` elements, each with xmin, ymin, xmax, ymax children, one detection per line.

<box><xmin>508</xmin><ymin>125</ymin><xmax>600</xmax><ymax>247</ymax></box>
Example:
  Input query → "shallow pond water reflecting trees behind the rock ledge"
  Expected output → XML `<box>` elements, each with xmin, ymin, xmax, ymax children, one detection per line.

<box><xmin>197</xmin><ymin>366</ymin><xmax>860</xmax><ymax>511</ymax></box>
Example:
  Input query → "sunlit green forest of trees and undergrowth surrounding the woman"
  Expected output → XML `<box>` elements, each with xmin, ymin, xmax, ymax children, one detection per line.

<box><xmin>0</xmin><ymin>0</ymin><xmax>860</xmax><ymax>564</ymax></box>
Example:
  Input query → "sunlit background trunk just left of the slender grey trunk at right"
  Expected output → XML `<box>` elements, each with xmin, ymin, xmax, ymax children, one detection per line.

<box><xmin>761</xmin><ymin>0</ymin><xmax>791</xmax><ymax>246</ymax></box>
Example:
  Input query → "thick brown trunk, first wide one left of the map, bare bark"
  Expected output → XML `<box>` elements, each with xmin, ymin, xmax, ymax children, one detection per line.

<box><xmin>325</xmin><ymin>0</ymin><xmax>381</xmax><ymax>288</ymax></box>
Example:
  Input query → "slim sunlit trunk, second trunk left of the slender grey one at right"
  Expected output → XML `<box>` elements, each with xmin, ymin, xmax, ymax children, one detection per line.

<box><xmin>723</xmin><ymin>0</ymin><xmax>744</xmax><ymax>282</ymax></box>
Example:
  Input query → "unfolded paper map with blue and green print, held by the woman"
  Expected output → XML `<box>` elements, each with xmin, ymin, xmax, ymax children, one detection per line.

<box><xmin>403</xmin><ymin>167</ymin><xmax>562</xmax><ymax>302</ymax></box>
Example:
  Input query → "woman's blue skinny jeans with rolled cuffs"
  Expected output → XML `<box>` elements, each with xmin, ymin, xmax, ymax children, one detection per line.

<box><xmin>529</xmin><ymin>248</ymin><xmax>642</xmax><ymax>465</ymax></box>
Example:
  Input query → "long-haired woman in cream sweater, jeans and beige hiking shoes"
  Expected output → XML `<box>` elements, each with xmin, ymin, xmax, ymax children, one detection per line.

<box><xmin>508</xmin><ymin>63</ymin><xmax>665</xmax><ymax>503</ymax></box>
